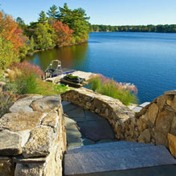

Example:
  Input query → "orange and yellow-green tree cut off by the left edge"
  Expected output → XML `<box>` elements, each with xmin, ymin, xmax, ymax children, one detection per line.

<box><xmin>0</xmin><ymin>12</ymin><xmax>28</xmax><ymax>69</ymax></box>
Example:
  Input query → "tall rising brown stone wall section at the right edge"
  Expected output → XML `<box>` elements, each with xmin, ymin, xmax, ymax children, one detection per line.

<box><xmin>131</xmin><ymin>91</ymin><xmax>176</xmax><ymax>147</ymax></box>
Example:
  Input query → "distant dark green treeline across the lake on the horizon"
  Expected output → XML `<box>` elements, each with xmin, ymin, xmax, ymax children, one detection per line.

<box><xmin>91</xmin><ymin>24</ymin><xmax>176</xmax><ymax>33</ymax></box>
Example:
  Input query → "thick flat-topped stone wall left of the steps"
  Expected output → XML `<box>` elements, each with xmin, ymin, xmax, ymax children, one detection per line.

<box><xmin>0</xmin><ymin>95</ymin><xmax>66</xmax><ymax>176</ymax></box>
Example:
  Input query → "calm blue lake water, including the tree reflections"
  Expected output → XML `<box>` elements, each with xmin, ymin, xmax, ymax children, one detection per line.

<box><xmin>27</xmin><ymin>32</ymin><xmax>176</xmax><ymax>103</ymax></box>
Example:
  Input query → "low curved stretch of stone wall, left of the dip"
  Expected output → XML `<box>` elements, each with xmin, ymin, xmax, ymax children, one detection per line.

<box><xmin>62</xmin><ymin>88</ymin><xmax>135</xmax><ymax>140</ymax></box>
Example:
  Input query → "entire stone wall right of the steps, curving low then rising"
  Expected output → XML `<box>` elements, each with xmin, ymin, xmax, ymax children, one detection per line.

<box><xmin>62</xmin><ymin>88</ymin><xmax>176</xmax><ymax>156</ymax></box>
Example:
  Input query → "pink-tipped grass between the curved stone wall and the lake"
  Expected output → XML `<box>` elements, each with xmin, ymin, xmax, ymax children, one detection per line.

<box><xmin>89</xmin><ymin>75</ymin><xmax>137</xmax><ymax>105</ymax></box>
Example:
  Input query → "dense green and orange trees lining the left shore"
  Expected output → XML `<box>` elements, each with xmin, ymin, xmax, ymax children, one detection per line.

<box><xmin>0</xmin><ymin>4</ymin><xmax>90</xmax><ymax>69</ymax></box>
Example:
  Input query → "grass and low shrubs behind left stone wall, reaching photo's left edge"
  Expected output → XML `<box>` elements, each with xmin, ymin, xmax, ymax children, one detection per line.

<box><xmin>0</xmin><ymin>63</ymin><xmax>68</xmax><ymax>117</ymax></box>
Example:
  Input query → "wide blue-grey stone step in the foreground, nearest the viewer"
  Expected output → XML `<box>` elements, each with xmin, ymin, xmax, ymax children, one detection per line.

<box><xmin>64</xmin><ymin>141</ymin><xmax>176</xmax><ymax>176</ymax></box>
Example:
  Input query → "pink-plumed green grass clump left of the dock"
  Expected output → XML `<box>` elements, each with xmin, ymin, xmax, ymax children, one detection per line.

<box><xmin>6</xmin><ymin>62</ymin><xmax>67</xmax><ymax>95</ymax></box>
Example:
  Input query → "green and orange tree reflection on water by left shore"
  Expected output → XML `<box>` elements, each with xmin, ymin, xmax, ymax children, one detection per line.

<box><xmin>26</xmin><ymin>43</ymin><xmax>88</xmax><ymax>70</ymax></box>
